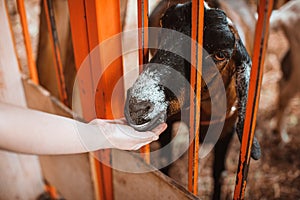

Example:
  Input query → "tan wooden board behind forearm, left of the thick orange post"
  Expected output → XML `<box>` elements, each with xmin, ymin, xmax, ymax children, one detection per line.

<box><xmin>23</xmin><ymin>80</ymin><xmax>95</xmax><ymax>200</ymax></box>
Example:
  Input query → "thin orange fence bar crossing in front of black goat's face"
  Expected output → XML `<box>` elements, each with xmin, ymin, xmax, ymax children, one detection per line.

<box><xmin>188</xmin><ymin>0</ymin><xmax>204</xmax><ymax>195</ymax></box>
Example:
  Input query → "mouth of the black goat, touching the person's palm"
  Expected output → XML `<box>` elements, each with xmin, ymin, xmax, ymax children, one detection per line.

<box><xmin>124</xmin><ymin>106</ymin><xmax>167</xmax><ymax>131</ymax></box>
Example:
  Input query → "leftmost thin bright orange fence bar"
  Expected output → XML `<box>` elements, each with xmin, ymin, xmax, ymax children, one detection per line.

<box><xmin>17</xmin><ymin>0</ymin><xmax>39</xmax><ymax>84</ymax></box>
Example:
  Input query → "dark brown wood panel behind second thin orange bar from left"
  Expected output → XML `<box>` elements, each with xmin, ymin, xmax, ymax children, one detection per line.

<box><xmin>36</xmin><ymin>0</ymin><xmax>76</xmax><ymax>105</ymax></box>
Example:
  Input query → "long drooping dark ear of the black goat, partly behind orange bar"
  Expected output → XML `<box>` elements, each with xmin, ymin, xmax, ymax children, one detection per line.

<box><xmin>229</xmin><ymin>24</ymin><xmax>261</xmax><ymax>160</ymax></box>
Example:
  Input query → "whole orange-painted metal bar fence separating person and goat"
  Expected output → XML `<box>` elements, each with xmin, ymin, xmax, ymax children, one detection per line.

<box><xmin>12</xmin><ymin>0</ymin><xmax>273</xmax><ymax>199</ymax></box>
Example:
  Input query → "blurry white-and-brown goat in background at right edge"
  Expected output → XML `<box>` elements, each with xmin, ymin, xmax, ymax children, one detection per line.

<box><xmin>270</xmin><ymin>1</ymin><xmax>300</xmax><ymax>142</ymax></box>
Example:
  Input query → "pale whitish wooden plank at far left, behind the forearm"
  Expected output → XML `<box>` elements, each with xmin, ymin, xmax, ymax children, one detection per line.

<box><xmin>0</xmin><ymin>1</ymin><xmax>43</xmax><ymax>200</ymax></box>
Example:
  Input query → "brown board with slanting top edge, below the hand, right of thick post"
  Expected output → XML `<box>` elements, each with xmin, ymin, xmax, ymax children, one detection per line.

<box><xmin>113</xmin><ymin>150</ymin><xmax>198</xmax><ymax>200</ymax></box>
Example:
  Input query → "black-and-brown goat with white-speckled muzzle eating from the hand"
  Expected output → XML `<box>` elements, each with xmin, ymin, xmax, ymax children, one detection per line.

<box><xmin>124</xmin><ymin>2</ymin><xmax>261</xmax><ymax>199</ymax></box>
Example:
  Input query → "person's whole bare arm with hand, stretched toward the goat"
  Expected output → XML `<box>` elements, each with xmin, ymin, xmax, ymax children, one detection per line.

<box><xmin>0</xmin><ymin>102</ymin><xmax>166</xmax><ymax>155</ymax></box>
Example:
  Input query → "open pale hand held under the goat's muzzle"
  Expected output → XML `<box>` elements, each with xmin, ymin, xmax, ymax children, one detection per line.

<box><xmin>89</xmin><ymin>118</ymin><xmax>167</xmax><ymax>150</ymax></box>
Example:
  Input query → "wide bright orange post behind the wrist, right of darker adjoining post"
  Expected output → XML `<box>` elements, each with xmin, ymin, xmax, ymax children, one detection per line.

<box><xmin>95</xmin><ymin>0</ymin><xmax>125</xmax><ymax>200</ymax></box>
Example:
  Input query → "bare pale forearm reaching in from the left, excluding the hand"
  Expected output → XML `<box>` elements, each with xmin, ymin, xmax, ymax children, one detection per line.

<box><xmin>0</xmin><ymin>102</ymin><xmax>96</xmax><ymax>154</ymax></box>
